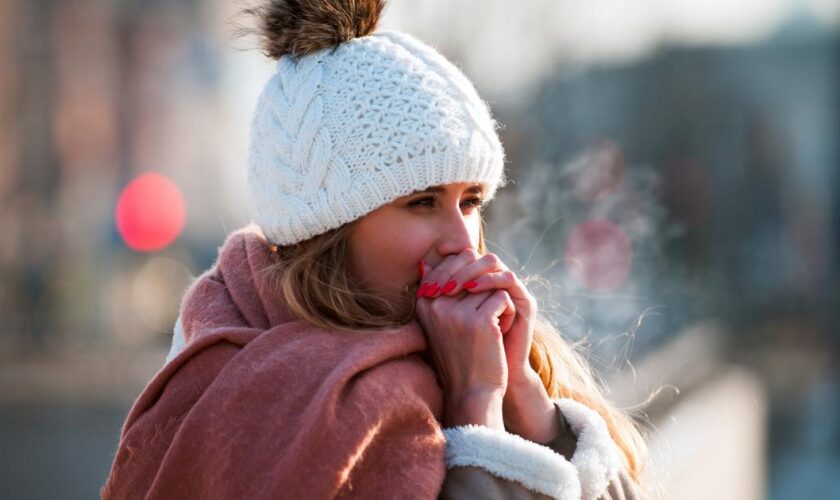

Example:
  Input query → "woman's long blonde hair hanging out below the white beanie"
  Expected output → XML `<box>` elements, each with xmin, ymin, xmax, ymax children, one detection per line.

<box><xmin>256</xmin><ymin>221</ymin><xmax>647</xmax><ymax>485</ymax></box>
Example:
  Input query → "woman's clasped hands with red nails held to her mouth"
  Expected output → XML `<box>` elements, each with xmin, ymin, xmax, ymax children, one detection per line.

<box><xmin>417</xmin><ymin>249</ymin><xmax>559</xmax><ymax>442</ymax></box>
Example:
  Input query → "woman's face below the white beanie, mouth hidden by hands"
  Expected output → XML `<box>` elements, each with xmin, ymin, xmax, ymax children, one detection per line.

<box><xmin>348</xmin><ymin>183</ymin><xmax>484</xmax><ymax>310</ymax></box>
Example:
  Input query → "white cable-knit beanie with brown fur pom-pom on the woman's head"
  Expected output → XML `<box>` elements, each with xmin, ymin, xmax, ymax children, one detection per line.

<box><xmin>247</xmin><ymin>0</ymin><xmax>505</xmax><ymax>245</ymax></box>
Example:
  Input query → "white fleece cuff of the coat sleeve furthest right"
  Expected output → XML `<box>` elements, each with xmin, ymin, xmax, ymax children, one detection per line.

<box><xmin>554</xmin><ymin>398</ymin><xmax>622</xmax><ymax>500</ymax></box>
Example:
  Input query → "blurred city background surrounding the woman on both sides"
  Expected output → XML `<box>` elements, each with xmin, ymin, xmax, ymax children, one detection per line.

<box><xmin>0</xmin><ymin>0</ymin><xmax>840</xmax><ymax>500</ymax></box>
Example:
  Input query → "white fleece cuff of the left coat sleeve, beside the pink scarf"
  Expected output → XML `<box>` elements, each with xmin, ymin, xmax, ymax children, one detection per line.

<box><xmin>443</xmin><ymin>425</ymin><xmax>581</xmax><ymax>500</ymax></box>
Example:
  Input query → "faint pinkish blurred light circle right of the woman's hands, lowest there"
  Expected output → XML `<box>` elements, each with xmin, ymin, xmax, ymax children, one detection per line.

<box><xmin>564</xmin><ymin>219</ymin><xmax>633</xmax><ymax>291</ymax></box>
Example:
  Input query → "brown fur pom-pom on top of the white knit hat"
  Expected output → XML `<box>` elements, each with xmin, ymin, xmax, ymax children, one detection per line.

<box><xmin>244</xmin><ymin>0</ymin><xmax>385</xmax><ymax>59</ymax></box>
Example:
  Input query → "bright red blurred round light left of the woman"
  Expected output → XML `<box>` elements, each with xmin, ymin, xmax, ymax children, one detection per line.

<box><xmin>116</xmin><ymin>173</ymin><xmax>186</xmax><ymax>252</ymax></box>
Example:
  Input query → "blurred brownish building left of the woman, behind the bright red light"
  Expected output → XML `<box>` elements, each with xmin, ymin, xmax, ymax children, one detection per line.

<box><xmin>0</xmin><ymin>0</ymin><xmax>253</xmax><ymax>356</ymax></box>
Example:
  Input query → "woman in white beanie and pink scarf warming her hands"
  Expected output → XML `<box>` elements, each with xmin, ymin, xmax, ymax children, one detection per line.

<box><xmin>102</xmin><ymin>0</ymin><xmax>643</xmax><ymax>499</ymax></box>
